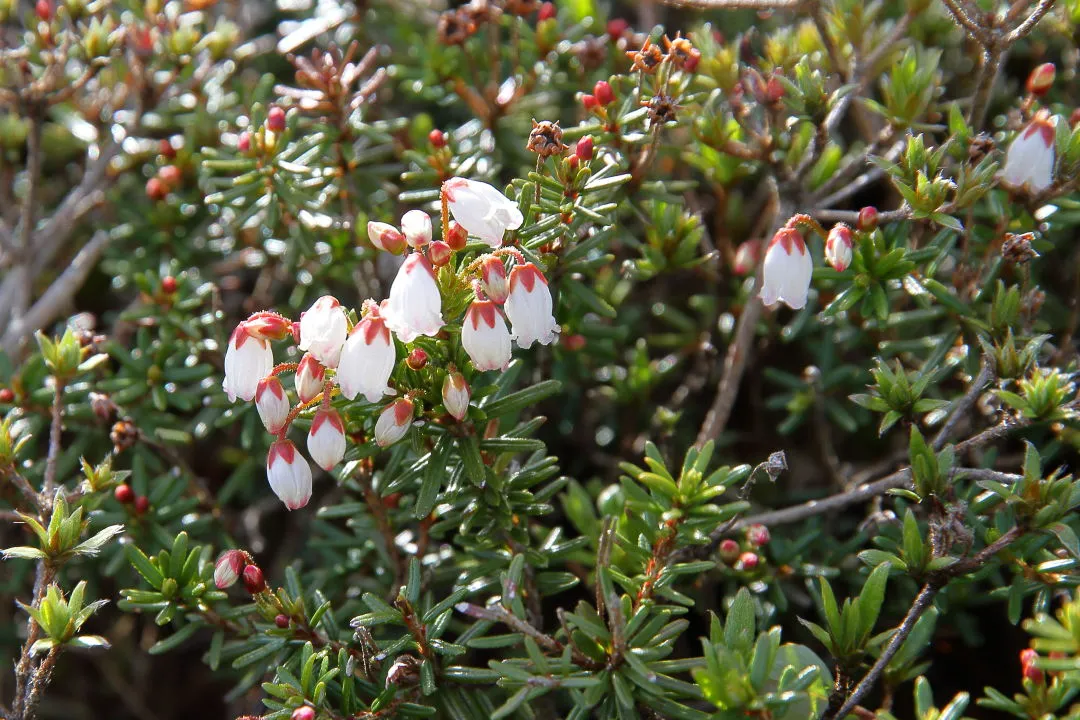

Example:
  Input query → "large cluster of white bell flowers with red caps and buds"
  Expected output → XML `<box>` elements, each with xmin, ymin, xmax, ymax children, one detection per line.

<box><xmin>222</xmin><ymin>178</ymin><xmax>559</xmax><ymax>510</ymax></box>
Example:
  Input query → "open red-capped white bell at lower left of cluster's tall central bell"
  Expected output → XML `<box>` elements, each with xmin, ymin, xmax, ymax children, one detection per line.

<box><xmin>337</xmin><ymin>302</ymin><xmax>397</xmax><ymax>403</ymax></box>
